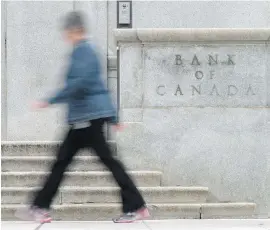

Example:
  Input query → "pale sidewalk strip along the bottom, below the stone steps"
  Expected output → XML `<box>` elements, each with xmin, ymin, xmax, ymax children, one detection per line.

<box><xmin>1</xmin><ymin>219</ymin><xmax>270</xmax><ymax>230</ymax></box>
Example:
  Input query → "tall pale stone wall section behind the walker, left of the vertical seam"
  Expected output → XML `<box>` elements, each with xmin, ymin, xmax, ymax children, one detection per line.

<box><xmin>1</xmin><ymin>1</ymin><xmax>112</xmax><ymax>141</ymax></box>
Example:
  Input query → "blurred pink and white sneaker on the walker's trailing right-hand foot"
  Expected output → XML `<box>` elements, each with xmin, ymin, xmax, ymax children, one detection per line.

<box><xmin>113</xmin><ymin>208</ymin><xmax>150</xmax><ymax>223</ymax></box>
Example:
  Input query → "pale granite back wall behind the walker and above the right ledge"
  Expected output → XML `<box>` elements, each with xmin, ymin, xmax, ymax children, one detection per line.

<box><xmin>1</xmin><ymin>1</ymin><xmax>270</xmax><ymax>141</ymax></box>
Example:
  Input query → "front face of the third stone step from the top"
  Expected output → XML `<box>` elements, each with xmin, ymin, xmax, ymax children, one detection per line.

<box><xmin>1</xmin><ymin>173</ymin><xmax>161</xmax><ymax>187</ymax></box>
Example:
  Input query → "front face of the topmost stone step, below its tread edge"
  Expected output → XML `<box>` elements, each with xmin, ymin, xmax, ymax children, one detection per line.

<box><xmin>1</xmin><ymin>142</ymin><xmax>116</xmax><ymax>156</ymax></box>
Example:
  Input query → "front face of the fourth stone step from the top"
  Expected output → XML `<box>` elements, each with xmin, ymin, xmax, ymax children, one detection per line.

<box><xmin>2</xmin><ymin>189</ymin><xmax>207</xmax><ymax>204</ymax></box>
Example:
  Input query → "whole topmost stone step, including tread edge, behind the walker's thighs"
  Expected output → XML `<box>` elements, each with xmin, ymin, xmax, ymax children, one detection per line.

<box><xmin>1</xmin><ymin>141</ymin><xmax>116</xmax><ymax>156</ymax></box>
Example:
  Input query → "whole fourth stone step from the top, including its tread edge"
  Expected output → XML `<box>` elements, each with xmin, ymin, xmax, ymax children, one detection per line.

<box><xmin>1</xmin><ymin>187</ymin><xmax>208</xmax><ymax>204</ymax></box>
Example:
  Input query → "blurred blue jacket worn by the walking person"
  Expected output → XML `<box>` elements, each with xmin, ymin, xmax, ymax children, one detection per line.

<box><xmin>48</xmin><ymin>40</ymin><xmax>118</xmax><ymax>124</ymax></box>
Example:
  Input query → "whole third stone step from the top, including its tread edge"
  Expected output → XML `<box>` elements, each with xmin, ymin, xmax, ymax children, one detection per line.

<box><xmin>1</xmin><ymin>171</ymin><xmax>161</xmax><ymax>187</ymax></box>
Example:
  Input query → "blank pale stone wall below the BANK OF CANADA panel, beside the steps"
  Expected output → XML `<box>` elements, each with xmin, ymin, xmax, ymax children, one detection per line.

<box><xmin>118</xmin><ymin>108</ymin><xmax>270</xmax><ymax>216</ymax></box>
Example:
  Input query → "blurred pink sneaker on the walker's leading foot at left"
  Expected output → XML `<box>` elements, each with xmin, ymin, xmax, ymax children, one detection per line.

<box><xmin>15</xmin><ymin>207</ymin><xmax>52</xmax><ymax>224</ymax></box>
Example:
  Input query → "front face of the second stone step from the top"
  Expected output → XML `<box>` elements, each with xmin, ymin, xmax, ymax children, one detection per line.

<box><xmin>1</xmin><ymin>160</ymin><xmax>106</xmax><ymax>172</ymax></box>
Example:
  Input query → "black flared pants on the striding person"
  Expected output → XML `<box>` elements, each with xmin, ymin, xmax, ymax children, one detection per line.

<box><xmin>33</xmin><ymin>119</ymin><xmax>145</xmax><ymax>213</ymax></box>
